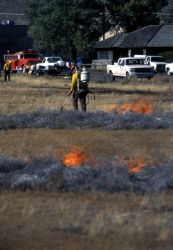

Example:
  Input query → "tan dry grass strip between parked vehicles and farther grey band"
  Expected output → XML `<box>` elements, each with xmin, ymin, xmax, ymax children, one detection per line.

<box><xmin>0</xmin><ymin>74</ymin><xmax>173</xmax><ymax>114</ymax></box>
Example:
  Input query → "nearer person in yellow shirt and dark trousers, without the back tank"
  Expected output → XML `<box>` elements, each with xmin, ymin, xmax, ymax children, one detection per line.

<box><xmin>67</xmin><ymin>68</ymin><xmax>88</xmax><ymax>112</ymax></box>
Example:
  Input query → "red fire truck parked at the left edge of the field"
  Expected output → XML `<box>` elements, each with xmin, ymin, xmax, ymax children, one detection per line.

<box><xmin>4</xmin><ymin>50</ymin><xmax>41</xmax><ymax>72</ymax></box>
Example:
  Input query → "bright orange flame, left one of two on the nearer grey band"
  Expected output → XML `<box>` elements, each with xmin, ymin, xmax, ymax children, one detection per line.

<box><xmin>64</xmin><ymin>147</ymin><xmax>87</xmax><ymax>167</ymax></box>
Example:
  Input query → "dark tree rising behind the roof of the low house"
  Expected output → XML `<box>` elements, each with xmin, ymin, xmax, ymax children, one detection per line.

<box><xmin>106</xmin><ymin>0</ymin><xmax>167</xmax><ymax>32</ymax></box>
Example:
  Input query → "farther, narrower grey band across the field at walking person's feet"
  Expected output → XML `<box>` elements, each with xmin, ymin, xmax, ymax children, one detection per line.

<box><xmin>0</xmin><ymin>109</ymin><xmax>173</xmax><ymax>130</ymax></box>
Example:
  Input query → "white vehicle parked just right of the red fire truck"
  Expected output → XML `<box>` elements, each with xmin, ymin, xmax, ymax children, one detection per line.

<box><xmin>36</xmin><ymin>56</ymin><xmax>65</xmax><ymax>70</ymax></box>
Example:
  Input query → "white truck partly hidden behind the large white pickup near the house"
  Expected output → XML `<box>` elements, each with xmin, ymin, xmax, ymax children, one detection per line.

<box><xmin>134</xmin><ymin>55</ymin><xmax>166</xmax><ymax>73</ymax></box>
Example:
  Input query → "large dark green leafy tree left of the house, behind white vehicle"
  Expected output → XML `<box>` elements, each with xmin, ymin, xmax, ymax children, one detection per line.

<box><xmin>25</xmin><ymin>0</ymin><xmax>106</xmax><ymax>57</ymax></box>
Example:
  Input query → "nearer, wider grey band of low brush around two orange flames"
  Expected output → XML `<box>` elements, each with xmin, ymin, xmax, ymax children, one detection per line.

<box><xmin>0</xmin><ymin>155</ymin><xmax>173</xmax><ymax>193</ymax></box>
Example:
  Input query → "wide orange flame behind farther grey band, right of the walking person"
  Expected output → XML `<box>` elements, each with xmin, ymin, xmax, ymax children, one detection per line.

<box><xmin>102</xmin><ymin>99</ymin><xmax>153</xmax><ymax>113</ymax></box>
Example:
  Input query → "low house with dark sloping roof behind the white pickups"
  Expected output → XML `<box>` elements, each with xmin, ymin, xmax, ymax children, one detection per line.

<box><xmin>94</xmin><ymin>24</ymin><xmax>173</xmax><ymax>66</ymax></box>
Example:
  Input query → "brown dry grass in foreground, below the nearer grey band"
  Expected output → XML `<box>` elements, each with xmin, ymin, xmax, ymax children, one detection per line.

<box><xmin>0</xmin><ymin>189</ymin><xmax>173</xmax><ymax>250</ymax></box>
